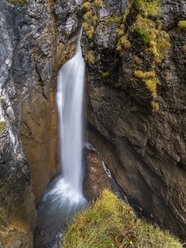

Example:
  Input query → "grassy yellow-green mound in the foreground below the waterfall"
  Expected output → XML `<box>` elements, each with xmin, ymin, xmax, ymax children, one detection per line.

<box><xmin>63</xmin><ymin>190</ymin><xmax>182</xmax><ymax>248</ymax></box>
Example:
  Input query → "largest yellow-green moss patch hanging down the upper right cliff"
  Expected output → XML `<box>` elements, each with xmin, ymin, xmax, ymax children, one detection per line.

<box><xmin>116</xmin><ymin>0</ymin><xmax>171</xmax><ymax>112</ymax></box>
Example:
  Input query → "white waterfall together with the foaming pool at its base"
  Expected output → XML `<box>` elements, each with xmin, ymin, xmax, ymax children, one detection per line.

<box><xmin>35</xmin><ymin>32</ymin><xmax>87</xmax><ymax>248</ymax></box>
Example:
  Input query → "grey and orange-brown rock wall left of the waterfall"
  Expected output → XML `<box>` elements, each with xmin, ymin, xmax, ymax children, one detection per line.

<box><xmin>0</xmin><ymin>0</ymin><xmax>80</xmax><ymax>248</ymax></box>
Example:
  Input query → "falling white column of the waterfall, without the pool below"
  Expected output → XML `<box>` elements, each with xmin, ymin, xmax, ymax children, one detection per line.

<box><xmin>56</xmin><ymin>33</ymin><xmax>85</xmax><ymax>194</ymax></box>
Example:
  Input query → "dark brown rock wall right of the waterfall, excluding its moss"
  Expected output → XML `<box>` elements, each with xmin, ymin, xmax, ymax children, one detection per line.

<box><xmin>83</xmin><ymin>0</ymin><xmax>186</xmax><ymax>242</ymax></box>
